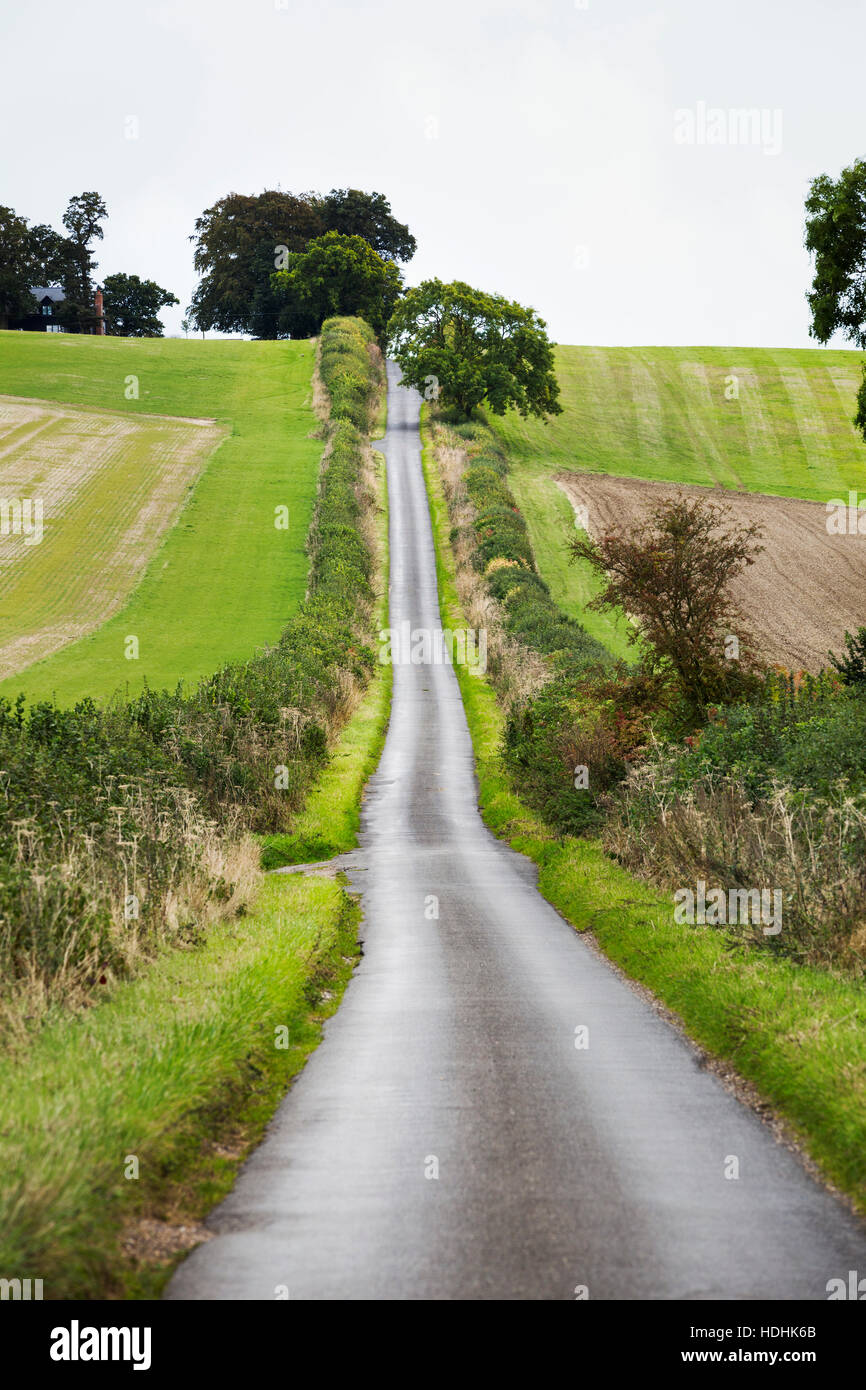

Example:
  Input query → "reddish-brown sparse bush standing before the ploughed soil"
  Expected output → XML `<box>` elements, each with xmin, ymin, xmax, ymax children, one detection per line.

<box><xmin>570</xmin><ymin>496</ymin><xmax>763</xmax><ymax>719</ymax></box>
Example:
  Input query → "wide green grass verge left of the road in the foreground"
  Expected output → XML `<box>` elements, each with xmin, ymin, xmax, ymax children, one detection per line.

<box><xmin>0</xmin><ymin>876</ymin><xmax>359</xmax><ymax>1298</ymax></box>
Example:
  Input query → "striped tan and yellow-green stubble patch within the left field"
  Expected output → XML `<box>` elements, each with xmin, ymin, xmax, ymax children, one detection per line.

<box><xmin>0</xmin><ymin>396</ymin><xmax>225</xmax><ymax>678</ymax></box>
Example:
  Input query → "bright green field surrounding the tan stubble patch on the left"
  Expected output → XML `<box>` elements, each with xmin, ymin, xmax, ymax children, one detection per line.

<box><xmin>0</xmin><ymin>332</ymin><xmax>321</xmax><ymax>703</ymax></box>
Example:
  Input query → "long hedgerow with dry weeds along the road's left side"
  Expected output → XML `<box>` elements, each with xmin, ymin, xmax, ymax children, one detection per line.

<box><xmin>0</xmin><ymin>318</ymin><xmax>382</xmax><ymax>1023</ymax></box>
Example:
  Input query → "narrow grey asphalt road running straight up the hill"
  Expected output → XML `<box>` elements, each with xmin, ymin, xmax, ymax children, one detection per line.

<box><xmin>168</xmin><ymin>367</ymin><xmax>866</xmax><ymax>1300</ymax></box>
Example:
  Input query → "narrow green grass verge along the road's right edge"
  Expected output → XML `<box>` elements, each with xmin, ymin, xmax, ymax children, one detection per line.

<box><xmin>423</xmin><ymin>405</ymin><xmax>866</xmax><ymax>1212</ymax></box>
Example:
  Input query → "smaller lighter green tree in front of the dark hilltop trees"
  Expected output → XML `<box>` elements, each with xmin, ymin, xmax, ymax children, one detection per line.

<box><xmin>274</xmin><ymin>232</ymin><xmax>403</xmax><ymax>336</ymax></box>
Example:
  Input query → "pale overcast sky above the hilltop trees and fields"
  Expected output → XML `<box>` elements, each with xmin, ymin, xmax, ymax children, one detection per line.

<box><xmin>0</xmin><ymin>0</ymin><xmax>866</xmax><ymax>348</ymax></box>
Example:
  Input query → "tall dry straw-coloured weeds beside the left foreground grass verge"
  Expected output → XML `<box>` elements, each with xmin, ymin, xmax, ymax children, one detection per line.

<box><xmin>0</xmin><ymin>781</ymin><xmax>261</xmax><ymax>1034</ymax></box>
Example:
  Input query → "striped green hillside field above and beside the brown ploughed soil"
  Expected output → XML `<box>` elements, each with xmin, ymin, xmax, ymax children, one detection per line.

<box><xmin>489</xmin><ymin>348</ymin><xmax>866</xmax><ymax>655</ymax></box>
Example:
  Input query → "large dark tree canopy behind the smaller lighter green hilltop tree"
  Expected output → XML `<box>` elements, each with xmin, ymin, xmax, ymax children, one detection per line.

<box><xmin>189</xmin><ymin>189</ymin><xmax>416</xmax><ymax>338</ymax></box>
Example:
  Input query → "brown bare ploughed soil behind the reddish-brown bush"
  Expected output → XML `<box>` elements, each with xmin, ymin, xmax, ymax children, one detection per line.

<box><xmin>556</xmin><ymin>473</ymin><xmax>866</xmax><ymax>671</ymax></box>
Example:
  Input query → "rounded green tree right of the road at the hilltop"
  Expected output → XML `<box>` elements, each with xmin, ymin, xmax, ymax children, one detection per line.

<box><xmin>388</xmin><ymin>279</ymin><xmax>562</xmax><ymax>418</ymax></box>
